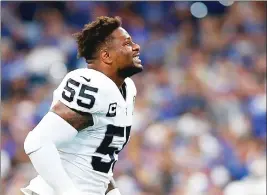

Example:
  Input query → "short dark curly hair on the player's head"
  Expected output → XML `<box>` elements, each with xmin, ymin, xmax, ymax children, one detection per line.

<box><xmin>73</xmin><ymin>16</ymin><xmax>121</xmax><ymax>61</ymax></box>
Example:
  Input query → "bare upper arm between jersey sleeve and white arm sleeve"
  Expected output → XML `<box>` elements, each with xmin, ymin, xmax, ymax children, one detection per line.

<box><xmin>50</xmin><ymin>101</ymin><xmax>93</xmax><ymax>131</ymax></box>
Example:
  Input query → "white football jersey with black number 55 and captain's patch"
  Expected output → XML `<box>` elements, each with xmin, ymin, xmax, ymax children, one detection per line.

<box><xmin>22</xmin><ymin>68</ymin><xmax>136</xmax><ymax>195</ymax></box>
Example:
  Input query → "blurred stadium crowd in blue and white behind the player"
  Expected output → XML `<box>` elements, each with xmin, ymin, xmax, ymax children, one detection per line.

<box><xmin>1</xmin><ymin>1</ymin><xmax>266</xmax><ymax>195</ymax></box>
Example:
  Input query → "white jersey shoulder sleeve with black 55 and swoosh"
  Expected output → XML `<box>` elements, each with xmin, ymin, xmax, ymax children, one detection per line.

<box><xmin>53</xmin><ymin>71</ymin><xmax>101</xmax><ymax>114</ymax></box>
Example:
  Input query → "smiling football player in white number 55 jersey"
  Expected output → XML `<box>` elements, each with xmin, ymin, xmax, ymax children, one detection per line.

<box><xmin>21</xmin><ymin>16</ymin><xmax>143</xmax><ymax>195</ymax></box>
